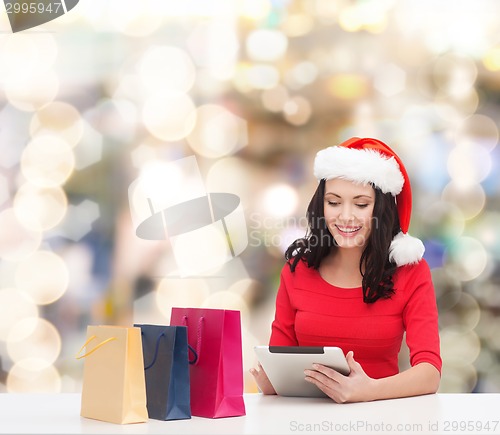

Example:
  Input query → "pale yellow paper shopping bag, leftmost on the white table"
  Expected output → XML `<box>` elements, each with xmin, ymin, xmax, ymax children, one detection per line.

<box><xmin>77</xmin><ymin>326</ymin><xmax>148</xmax><ymax>424</ymax></box>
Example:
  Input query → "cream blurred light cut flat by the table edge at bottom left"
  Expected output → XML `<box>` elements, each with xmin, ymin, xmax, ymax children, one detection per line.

<box><xmin>7</xmin><ymin>358</ymin><xmax>61</xmax><ymax>393</ymax></box>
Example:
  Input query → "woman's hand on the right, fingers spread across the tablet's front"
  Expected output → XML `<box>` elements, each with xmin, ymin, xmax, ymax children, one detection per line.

<box><xmin>304</xmin><ymin>351</ymin><xmax>375</xmax><ymax>403</ymax></box>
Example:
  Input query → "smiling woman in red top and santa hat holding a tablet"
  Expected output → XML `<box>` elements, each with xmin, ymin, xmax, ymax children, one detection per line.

<box><xmin>251</xmin><ymin>138</ymin><xmax>442</xmax><ymax>402</ymax></box>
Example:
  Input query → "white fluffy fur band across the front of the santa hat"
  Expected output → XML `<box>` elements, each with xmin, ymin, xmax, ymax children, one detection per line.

<box><xmin>314</xmin><ymin>146</ymin><xmax>404</xmax><ymax>196</ymax></box>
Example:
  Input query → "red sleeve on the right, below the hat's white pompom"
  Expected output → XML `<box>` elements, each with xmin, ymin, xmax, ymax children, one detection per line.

<box><xmin>403</xmin><ymin>260</ymin><xmax>442</xmax><ymax>373</ymax></box>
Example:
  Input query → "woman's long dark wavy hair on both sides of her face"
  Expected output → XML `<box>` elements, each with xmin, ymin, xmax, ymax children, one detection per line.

<box><xmin>285</xmin><ymin>180</ymin><xmax>400</xmax><ymax>303</ymax></box>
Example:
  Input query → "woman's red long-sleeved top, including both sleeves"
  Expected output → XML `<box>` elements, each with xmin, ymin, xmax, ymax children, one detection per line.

<box><xmin>269</xmin><ymin>260</ymin><xmax>442</xmax><ymax>378</ymax></box>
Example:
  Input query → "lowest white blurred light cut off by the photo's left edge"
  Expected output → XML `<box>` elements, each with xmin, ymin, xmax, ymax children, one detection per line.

<box><xmin>0</xmin><ymin>288</ymin><xmax>38</xmax><ymax>341</ymax></box>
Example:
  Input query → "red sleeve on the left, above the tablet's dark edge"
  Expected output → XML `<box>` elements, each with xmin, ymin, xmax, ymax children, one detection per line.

<box><xmin>269</xmin><ymin>264</ymin><xmax>299</xmax><ymax>346</ymax></box>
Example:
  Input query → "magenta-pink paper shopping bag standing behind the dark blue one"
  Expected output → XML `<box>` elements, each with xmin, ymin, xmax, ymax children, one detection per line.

<box><xmin>170</xmin><ymin>307</ymin><xmax>245</xmax><ymax>418</ymax></box>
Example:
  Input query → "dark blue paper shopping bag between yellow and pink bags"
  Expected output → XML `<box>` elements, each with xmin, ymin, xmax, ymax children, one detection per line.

<box><xmin>134</xmin><ymin>325</ymin><xmax>191</xmax><ymax>420</ymax></box>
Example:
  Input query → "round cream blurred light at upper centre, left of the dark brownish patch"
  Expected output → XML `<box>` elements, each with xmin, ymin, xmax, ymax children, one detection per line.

<box><xmin>187</xmin><ymin>104</ymin><xmax>248</xmax><ymax>158</ymax></box>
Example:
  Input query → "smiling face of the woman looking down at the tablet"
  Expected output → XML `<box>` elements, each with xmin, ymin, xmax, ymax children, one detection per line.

<box><xmin>324</xmin><ymin>178</ymin><xmax>375</xmax><ymax>248</ymax></box>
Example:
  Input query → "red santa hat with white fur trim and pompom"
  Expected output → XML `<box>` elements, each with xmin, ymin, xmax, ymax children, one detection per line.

<box><xmin>314</xmin><ymin>137</ymin><xmax>425</xmax><ymax>266</ymax></box>
